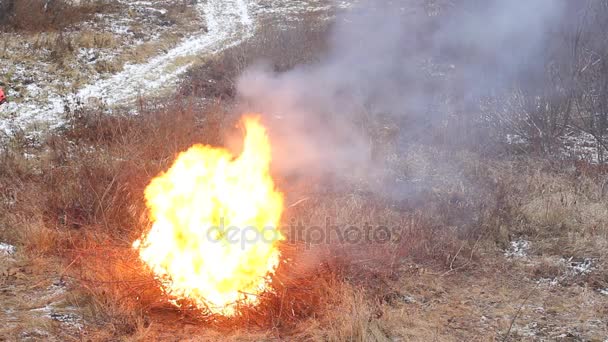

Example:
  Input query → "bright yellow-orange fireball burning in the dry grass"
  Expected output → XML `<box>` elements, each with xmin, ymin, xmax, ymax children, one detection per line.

<box><xmin>133</xmin><ymin>116</ymin><xmax>284</xmax><ymax>316</ymax></box>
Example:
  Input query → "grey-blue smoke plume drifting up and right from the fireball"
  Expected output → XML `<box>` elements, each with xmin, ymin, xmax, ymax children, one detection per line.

<box><xmin>238</xmin><ymin>0</ymin><xmax>567</xmax><ymax>184</ymax></box>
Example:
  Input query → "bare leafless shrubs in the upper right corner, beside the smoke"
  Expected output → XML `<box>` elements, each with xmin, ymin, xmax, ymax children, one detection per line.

<box><xmin>484</xmin><ymin>0</ymin><xmax>608</xmax><ymax>163</ymax></box>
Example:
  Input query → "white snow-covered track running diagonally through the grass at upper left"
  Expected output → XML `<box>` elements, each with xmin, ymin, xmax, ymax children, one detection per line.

<box><xmin>0</xmin><ymin>0</ymin><xmax>255</xmax><ymax>135</ymax></box>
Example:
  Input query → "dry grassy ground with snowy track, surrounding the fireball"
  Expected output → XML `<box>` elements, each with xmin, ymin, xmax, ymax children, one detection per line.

<box><xmin>0</xmin><ymin>0</ymin><xmax>608</xmax><ymax>341</ymax></box>
